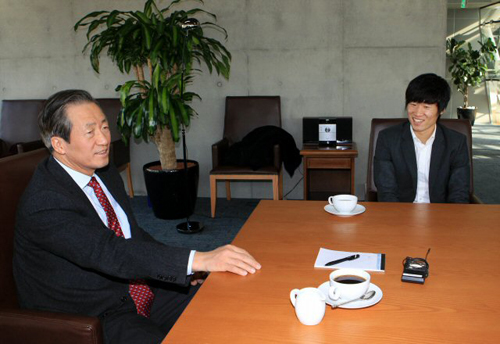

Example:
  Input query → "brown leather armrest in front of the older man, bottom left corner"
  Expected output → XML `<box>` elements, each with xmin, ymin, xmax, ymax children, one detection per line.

<box><xmin>0</xmin><ymin>309</ymin><xmax>103</xmax><ymax>344</ymax></box>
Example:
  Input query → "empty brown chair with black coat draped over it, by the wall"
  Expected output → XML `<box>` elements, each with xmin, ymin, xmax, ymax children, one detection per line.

<box><xmin>210</xmin><ymin>96</ymin><xmax>283</xmax><ymax>217</ymax></box>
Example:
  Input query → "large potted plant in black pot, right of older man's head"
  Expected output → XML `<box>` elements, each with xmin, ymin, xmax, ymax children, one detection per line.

<box><xmin>74</xmin><ymin>0</ymin><xmax>231</xmax><ymax>219</ymax></box>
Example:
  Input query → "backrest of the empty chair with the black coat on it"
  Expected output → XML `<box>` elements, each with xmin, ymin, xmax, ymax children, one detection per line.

<box><xmin>224</xmin><ymin>96</ymin><xmax>281</xmax><ymax>144</ymax></box>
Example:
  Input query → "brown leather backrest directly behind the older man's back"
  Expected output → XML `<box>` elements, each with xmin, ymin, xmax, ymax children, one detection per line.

<box><xmin>0</xmin><ymin>148</ymin><xmax>49</xmax><ymax>308</ymax></box>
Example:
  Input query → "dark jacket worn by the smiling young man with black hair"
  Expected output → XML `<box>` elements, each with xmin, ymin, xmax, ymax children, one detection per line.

<box><xmin>374</xmin><ymin>122</ymin><xmax>470</xmax><ymax>203</ymax></box>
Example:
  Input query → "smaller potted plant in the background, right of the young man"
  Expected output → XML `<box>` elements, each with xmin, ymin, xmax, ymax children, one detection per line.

<box><xmin>446</xmin><ymin>38</ymin><xmax>497</xmax><ymax>125</ymax></box>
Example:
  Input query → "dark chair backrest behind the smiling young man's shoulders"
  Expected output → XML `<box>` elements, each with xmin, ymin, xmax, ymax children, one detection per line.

<box><xmin>365</xmin><ymin>118</ymin><xmax>474</xmax><ymax>202</ymax></box>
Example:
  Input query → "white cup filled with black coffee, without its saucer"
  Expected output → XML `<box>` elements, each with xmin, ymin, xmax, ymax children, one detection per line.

<box><xmin>328</xmin><ymin>269</ymin><xmax>370</xmax><ymax>300</ymax></box>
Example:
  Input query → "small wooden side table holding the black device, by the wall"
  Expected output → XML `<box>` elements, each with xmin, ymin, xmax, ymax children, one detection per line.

<box><xmin>300</xmin><ymin>143</ymin><xmax>358</xmax><ymax>201</ymax></box>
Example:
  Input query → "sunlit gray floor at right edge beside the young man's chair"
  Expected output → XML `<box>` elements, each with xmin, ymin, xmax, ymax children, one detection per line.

<box><xmin>472</xmin><ymin>124</ymin><xmax>500</xmax><ymax>204</ymax></box>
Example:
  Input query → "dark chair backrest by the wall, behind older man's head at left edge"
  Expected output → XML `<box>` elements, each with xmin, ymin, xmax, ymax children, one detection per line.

<box><xmin>0</xmin><ymin>99</ymin><xmax>45</xmax><ymax>153</ymax></box>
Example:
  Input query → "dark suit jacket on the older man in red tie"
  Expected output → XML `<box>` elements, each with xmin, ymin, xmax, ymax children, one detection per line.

<box><xmin>14</xmin><ymin>156</ymin><xmax>190</xmax><ymax>316</ymax></box>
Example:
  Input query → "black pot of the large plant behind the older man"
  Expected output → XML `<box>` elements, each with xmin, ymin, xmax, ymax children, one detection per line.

<box><xmin>142</xmin><ymin>160</ymin><xmax>200</xmax><ymax>220</ymax></box>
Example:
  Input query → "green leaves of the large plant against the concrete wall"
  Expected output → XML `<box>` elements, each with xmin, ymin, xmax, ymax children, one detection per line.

<box><xmin>74</xmin><ymin>0</ymin><xmax>231</xmax><ymax>142</ymax></box>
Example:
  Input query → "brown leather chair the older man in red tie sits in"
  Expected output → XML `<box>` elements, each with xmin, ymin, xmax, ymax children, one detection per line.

<box><xmin>0</xmin><ymin>148</ymin><xmax>103</xmax><ymax>344</ymax></box>
